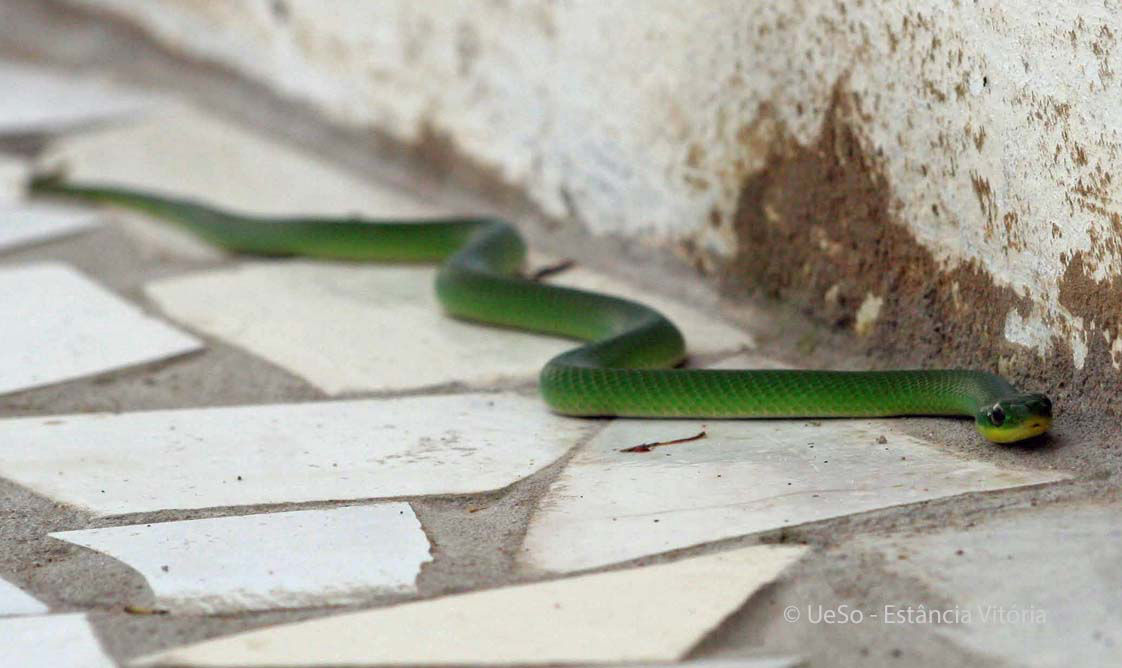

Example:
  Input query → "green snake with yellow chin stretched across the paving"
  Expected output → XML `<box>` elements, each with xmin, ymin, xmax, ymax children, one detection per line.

<box><xmin>31</xmin><ymin>176</ymin><xmax>1051</xmax><ymax>442</ymax></box>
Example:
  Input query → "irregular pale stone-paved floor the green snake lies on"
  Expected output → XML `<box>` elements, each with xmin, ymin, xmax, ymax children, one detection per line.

<box><xmin>0</xmin><ymin>56</ymin><xmax>1104</xmax><ymax>668</ymax></box>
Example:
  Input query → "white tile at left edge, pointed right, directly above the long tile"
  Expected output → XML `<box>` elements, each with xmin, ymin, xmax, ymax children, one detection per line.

<box><xmin>0</xmin><ymin>263</ymin><xmax>202</xmax><ymax>394</ymax></box>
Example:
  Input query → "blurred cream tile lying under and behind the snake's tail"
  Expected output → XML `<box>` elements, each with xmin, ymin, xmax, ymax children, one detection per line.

<box><xmin>43</xmin><ymin>104</ymin><xmax>448</xmax><ymax>259</ymax></box>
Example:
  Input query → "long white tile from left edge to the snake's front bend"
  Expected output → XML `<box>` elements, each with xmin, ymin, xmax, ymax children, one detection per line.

<box><xmin>0</xmin><ymin>394</ymin><xmax>595</xmax><ymax>514</ymax></box>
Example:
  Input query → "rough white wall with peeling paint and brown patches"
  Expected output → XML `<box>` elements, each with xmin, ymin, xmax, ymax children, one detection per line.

<box><xmin>63</xmin><ymin>0</ymin><xmax>1122</xmax><ymax>395</ymax></box>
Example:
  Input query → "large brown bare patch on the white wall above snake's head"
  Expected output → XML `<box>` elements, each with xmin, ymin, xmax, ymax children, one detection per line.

<box><xmin>723</xmin><ymin>85</ymin><xmax>1095</xmax><ymax>408</ymax></box>
